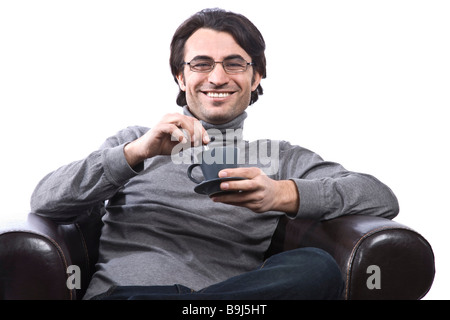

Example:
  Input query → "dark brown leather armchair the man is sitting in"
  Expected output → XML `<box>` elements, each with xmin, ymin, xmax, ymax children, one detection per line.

<box><xmin>0</xmin><ymin>213</ymin><xmax>435</xmax><ymax>300</ymax></box>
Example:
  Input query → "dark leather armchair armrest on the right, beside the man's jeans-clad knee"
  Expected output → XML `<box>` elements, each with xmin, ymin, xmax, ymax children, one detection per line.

<box><xmin>270</xmin><ymin>215</ymin><xmax>435</xmax><ymax>299</ymax></box>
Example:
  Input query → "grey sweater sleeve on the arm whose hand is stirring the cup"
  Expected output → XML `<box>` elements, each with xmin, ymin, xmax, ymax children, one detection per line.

<box><xmin>31</xmin><ymin>128</ymin><xmax>148</xmax><ymax>222</ymax></box>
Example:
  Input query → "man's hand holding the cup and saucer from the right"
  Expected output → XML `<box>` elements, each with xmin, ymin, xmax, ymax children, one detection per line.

<box><xmin>212</xmin><ymin>168</ymin><xmax>300</xmax><ymax>214</ymax></box>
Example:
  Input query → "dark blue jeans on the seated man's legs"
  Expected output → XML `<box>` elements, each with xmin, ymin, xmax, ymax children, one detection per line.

<box><xmin>93</xmin><ymin>248</ymin><xmax>344</xmax><ymax>300</ymax></box>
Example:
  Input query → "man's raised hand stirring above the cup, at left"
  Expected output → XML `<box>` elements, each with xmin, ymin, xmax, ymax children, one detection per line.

<box><xmin>124</xmin><ymin>113</ymin><xmax>210</xmax><ymax>167</ymax></box>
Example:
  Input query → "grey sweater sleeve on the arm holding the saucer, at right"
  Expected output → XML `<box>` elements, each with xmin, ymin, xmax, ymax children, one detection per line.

<box><xmin>279</xmin><ymin>143</ymin><xmax>399</xmax><ymax>220</ymax></box>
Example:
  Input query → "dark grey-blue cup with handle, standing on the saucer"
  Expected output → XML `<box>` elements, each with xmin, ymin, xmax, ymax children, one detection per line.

<box><xmin>187</xmin><ymin>147</ymin><xmax>239</xmax><ymax>184</ymax></box>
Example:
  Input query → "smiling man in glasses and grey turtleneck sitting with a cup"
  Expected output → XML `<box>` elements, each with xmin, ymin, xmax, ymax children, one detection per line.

<box><xmin>31</xmin><ymin>9</ymin><xmax>398</xmax><ymax>299</ymax></box>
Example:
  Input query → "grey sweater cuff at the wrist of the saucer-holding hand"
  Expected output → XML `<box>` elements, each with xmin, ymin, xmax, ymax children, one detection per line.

<box><xmin>288</xmin><ymin>179</ymin><xmax>326</xmax><ymax>219</ymax></box>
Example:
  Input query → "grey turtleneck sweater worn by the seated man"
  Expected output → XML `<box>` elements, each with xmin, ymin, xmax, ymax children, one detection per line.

<box><xmin>31</xmin><ymin>108</ymin><xmax>398</xmax><ymax>299</ymax></box>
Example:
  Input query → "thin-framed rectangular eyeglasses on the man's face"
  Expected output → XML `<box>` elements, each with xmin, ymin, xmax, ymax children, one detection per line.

<box><xmin>184</xmin><ymin>57</ymin><xmax>254</xmax><ymax>74</ymax></box>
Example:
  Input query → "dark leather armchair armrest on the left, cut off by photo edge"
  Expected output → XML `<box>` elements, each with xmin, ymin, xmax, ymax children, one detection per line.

<box><xmin>0</xmin><ymin>213</ymin><xmax>101</xmax><ymax>300</ymax></box>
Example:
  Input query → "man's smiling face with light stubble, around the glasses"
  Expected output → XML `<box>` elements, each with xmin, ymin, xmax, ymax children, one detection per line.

<box><xmin>177</xmin><ymin>29</ymin><xmax>261</xmax><ymax>124</ymax></box>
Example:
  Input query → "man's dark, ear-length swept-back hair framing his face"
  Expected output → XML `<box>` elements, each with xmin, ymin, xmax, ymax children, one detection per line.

<box><xmin>170</xmin><ymin>9</ymin><xmax>266</xmax><ymax>106</ymax></box>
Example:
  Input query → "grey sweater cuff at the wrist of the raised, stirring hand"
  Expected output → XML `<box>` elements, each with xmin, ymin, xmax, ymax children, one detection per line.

<box><xmin>102</xmin><ymin>144</ymin><xmax>143</xmax><ymax>186</ymax></box>
